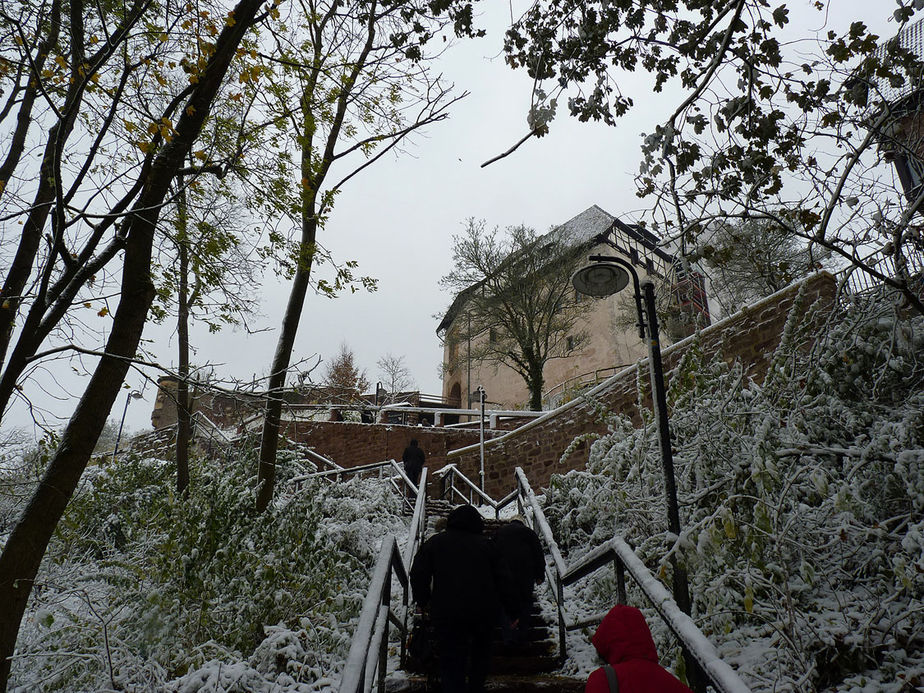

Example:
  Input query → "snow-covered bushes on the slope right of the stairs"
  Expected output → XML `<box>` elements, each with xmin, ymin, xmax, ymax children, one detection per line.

<box><xmin>546</xmin><ymin>294</ymin><xmax>924</xmax><ymax>692</ymax></box>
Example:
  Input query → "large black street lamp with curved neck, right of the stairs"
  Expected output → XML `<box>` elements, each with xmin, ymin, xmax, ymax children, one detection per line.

<box><xmin>571</xmin><ymin>250</ymin><xmax>690</xmax><ymax>615</ymax></box>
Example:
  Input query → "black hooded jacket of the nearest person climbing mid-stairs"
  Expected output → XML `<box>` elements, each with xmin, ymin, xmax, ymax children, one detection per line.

<box><xmin>411</xmin><ymin>506</ymin><xmax>513</xmax><ymax>625</ymax></box>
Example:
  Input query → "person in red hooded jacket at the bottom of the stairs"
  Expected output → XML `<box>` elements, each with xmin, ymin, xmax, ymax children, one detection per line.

<box><xmin>584</xmin><ymin>604</ymin><xmax>692</xmax><ymax>693</ymax></box>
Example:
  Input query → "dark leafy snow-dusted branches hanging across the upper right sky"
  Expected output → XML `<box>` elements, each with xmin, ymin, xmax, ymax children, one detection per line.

<box><xmin>505</xmin><ymin>0</ymin><xmax>924</xmax><ymax>313</ymax></box>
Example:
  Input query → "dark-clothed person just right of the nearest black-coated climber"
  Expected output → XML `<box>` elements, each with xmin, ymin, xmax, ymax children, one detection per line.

<box><xmin>494</xmin><ymin>516</ymin><xmax>545</xmax><ymax>635</ymax></box>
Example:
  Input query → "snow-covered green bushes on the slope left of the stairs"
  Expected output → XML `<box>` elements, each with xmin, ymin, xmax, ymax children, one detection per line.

<box><xmin>12</xmin><ymin>446</ymin><xmax>401</xmax><ymax>691</ymax></box>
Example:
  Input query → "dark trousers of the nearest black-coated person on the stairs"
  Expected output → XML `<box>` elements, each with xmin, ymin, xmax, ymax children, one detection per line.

<box><xmin>434</xmin><ymin>623</ymin><xmax>493</xmax><ymax>693</ymax></box>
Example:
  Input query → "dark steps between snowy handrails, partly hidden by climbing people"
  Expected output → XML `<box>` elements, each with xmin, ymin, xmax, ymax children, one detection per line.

<box><xmin>387</xmin><ymin>500</ymin><xmax>584</xmax><ymax>693</ymax></box>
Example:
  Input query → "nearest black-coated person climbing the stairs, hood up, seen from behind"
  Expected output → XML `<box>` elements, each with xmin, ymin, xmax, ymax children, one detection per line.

<box><xmin>410</xmin><ymin>505</ymin><xmax>510</xmax><ymax>693</ymax></box>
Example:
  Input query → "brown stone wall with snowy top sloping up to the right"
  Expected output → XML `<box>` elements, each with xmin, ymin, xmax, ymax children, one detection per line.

<box><xmin>446</xmin><ymin>272</ymin><xmax>836</xmax><ymax>498</ymax></box>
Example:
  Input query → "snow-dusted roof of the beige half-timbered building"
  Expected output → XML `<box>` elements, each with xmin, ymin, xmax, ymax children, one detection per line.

<box><xmin>436</xmin><ymin>205</ymin><xmax>672</xmax><ymax>332</ymax></box>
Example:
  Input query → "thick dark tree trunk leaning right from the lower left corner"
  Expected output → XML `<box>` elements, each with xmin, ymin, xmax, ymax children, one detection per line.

<box><xmin>0</xmin><ymin>0</ymin><xmax>265</xmax><ymax>690</ymax></box>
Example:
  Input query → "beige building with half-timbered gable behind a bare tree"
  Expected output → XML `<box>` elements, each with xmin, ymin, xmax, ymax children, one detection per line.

<box><xmin>437</xmin><ymin>205</ymin><xmax>709</xmax><ymax>409</ymax></box>
